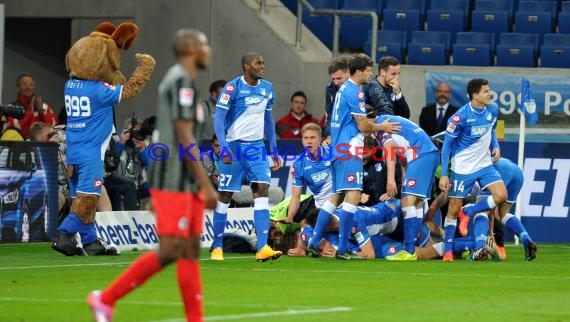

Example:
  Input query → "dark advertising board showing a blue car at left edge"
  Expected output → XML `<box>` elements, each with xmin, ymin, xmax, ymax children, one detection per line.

<box><xmin>0</xmin><ymin>141</ymin><xmax>58</xmax><ymax>242</ymax></box>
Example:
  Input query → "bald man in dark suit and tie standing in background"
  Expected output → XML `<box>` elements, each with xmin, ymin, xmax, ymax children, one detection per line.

<box><xmin>420</xmin><ymin>82</ymin><xmax>459</xmax><ymax>136</ymax></box>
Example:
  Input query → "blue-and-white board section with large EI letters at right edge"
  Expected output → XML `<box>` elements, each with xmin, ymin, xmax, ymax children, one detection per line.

<box><xmin>521</xmin><ymin>158</ymin><xmax>570</xmax><ymax>218</ymax></box>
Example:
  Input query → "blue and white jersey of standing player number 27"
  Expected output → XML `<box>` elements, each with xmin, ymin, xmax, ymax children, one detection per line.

<box><xmin>216</xmin><ymin>76</ymin><xmax>274</xmax><ymax>142</ymax></box>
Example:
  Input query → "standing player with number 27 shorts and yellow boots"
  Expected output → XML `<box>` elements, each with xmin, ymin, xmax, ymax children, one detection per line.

<box><xmin>210</xmin><ymin>52</ymin><xmax>282</xmax><ymax>262</ymax></box>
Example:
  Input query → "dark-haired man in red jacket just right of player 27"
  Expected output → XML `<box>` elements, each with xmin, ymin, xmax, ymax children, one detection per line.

<box><xmin>275</xmin><ymin>91</ymin><xmax>318</xmax><ymax>139</ymax></box>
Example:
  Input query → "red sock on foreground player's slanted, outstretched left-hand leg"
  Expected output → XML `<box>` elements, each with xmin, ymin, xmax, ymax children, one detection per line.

<box><xmin>101</xmin><ymin>252</ymin><xmax>162</xmax><ymax>305</ymax></box>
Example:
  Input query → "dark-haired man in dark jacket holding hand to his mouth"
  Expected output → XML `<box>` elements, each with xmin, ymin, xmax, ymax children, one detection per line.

<box><xmin>362</xmin><ymin>56</ymin><xmax>410</xmax><ymax>119</ymax></box>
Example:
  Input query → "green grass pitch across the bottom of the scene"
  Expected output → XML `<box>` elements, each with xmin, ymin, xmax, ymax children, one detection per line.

<box><xmin>0</xmin><ymin>243</ymin><xmax>570</xmax><ymax>322</ymax></box>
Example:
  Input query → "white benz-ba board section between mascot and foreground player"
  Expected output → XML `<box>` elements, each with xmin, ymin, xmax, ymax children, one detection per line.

<box><xmin>95</xmin><ymin>217</ymin><xmax>158</xmax><ymax>246</ymax></box>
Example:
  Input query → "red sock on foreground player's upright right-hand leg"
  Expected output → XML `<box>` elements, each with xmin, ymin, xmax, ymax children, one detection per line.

<box><xmin>177</xmin><ymin>259</ymin><xmax>202</xmax><ymax>322</ymax></box>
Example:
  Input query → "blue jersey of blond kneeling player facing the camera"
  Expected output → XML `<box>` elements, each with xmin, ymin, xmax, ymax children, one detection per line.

<box><xmin>291</xmin><ymin>147</ymin><xmax>332</xmax><ymax>208</ymax></box>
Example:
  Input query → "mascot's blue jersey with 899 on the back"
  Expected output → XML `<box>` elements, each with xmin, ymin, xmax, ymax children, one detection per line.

<box><xmin>63</xmin><ymin>79</ymin><xmax>123</xmax><ymax>164</ymax></box>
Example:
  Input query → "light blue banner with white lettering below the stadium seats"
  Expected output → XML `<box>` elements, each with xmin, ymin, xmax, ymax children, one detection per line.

<box><xmin>425</xmin><ymin>72</ymin><xmax>570</xmax><ymax>127</ymax></box>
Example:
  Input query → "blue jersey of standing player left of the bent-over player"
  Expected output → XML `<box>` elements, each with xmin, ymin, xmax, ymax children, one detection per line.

<box><xmin>331</xmin><ymin>79</ymin><xmax>366</xmax><ymax>155</ymax></box>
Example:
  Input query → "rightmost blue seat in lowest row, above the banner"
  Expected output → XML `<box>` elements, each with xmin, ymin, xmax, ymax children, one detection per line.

<box><xmin>540</xmin><ymin>34</ymin><xmax>570</xmax><ymax>68</ymax></box>
